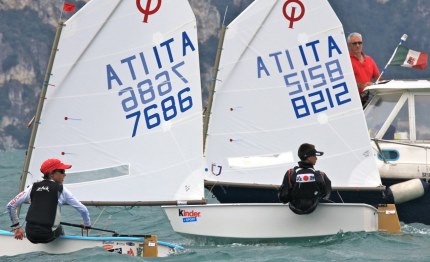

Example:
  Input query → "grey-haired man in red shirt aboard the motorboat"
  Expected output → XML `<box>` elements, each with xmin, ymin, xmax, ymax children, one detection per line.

<box><xmin>347</xmin><ymin>33</ymin><xmax>379</xmax><ymax>105</ymax></box>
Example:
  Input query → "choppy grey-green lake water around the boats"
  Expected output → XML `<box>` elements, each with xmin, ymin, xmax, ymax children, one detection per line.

<box><xmin>0</xmin><ymin>150</ymin><xmax>430</xmax><ymax>262</ymax></box>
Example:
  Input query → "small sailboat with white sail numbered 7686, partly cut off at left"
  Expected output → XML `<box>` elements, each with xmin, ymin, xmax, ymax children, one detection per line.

<box><xmin>0</xmin><ymin>0</ymin><xmax>205</xmax><ymax>256</ymax></box>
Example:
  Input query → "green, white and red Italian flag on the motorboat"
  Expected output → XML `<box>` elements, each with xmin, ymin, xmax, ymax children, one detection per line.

<box><xmin>390</xmin><ymin>45</ymin><xmax>428</xmax><ymax>70</ymax></box>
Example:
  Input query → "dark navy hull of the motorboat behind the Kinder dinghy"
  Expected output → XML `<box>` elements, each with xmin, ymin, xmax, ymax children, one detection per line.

<box><xmin>206</xmin><ymin>179</ymin><xmax>430</xmax><ymax>225</ymax></box>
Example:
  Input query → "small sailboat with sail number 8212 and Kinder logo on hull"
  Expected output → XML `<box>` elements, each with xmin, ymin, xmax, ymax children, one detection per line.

<box><xmin>163</xmin><ymin>0</ymin><xmax>399</xmax><ymax>240</ymax></box>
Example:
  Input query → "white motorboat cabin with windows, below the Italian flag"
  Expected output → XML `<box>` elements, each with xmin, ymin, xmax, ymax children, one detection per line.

<box><xmin>364</xmin><ymin>80</ymin><xmax>430</xmax><ymax>179</ymax></box>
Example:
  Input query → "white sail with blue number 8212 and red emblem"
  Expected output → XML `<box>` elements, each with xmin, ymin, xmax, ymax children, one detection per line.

<box><xmin>205</xmin><ymin>0</ymin><xmax>381</xmax><ymax>187</ymax></box>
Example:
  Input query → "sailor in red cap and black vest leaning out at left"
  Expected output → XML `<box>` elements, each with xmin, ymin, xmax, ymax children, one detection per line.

<box><xmin>6</xmin><ymin>159</ymin><xmax>91</xmax><ymax>244</ymax></box>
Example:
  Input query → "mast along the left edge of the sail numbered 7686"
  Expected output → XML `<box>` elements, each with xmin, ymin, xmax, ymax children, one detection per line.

<box><xmin>18</xmin><ymin>22</ymin><xmax>64</xmax><ymax>193</ymax></box>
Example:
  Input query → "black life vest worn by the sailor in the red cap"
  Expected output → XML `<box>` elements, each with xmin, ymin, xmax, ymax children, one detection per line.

<box><xmin>25</xmin><ymin>180</ymin><xmax>63</xmax><ymax>228</ymax></box>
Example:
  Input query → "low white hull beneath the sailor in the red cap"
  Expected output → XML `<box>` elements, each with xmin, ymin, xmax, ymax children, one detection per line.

<box><xmin>0</xmin><ymin>230</ymin><xmax>183</xmax><ymax>257</ymax></box>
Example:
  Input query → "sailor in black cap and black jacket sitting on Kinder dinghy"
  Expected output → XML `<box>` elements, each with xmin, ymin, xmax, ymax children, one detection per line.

<box><xmin>279</xmin><ymin>143</ymin><xmax>331</xmax><ymax>215</ymax></box>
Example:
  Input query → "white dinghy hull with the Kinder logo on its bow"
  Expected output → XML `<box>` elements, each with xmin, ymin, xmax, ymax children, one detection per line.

<box><xmin>163</xmin><ymin>204</ymin><xmax>378</xmax><ymax>239</ymax></box>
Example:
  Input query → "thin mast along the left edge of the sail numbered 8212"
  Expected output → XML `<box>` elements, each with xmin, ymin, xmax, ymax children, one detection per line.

<box><xmin>203</xmin><ymin>21</ymin><xmax>227</xmax><ymax>152</ymax></box>
